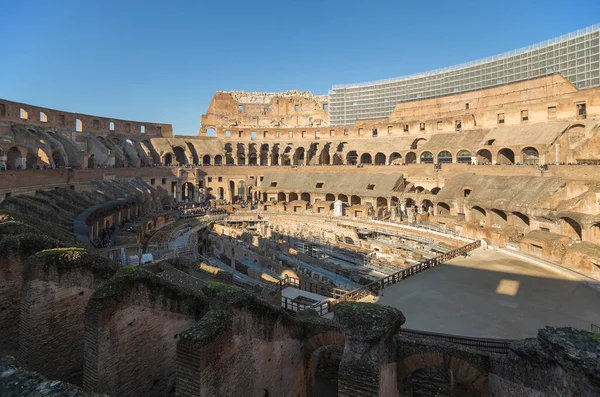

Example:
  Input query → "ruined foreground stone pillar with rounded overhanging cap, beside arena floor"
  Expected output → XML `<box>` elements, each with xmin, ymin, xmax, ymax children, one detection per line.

<box><xmin>334</xmin><ymin>302</ymin><xmax>406</xmax><ymax>397</ymax></box>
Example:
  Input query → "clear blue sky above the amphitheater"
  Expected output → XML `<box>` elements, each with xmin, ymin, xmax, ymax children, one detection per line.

<box><xmin>0</xmin><ymin>0</ymin><xmax>600</xmax><ymax>135</ymax></box>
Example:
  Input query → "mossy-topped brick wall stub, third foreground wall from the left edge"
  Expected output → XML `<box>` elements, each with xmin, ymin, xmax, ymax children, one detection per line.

<box><xmin>83</xmin><ymin>267</ymin><xmax>207</xmax><ymax>397</ymax></box>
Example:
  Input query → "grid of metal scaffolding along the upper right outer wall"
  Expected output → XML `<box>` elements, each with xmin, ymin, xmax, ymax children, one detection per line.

<box><xmin>329</xmin><ymin>24</ymin><xmax>600</xmax><ymax>125</ymax></box>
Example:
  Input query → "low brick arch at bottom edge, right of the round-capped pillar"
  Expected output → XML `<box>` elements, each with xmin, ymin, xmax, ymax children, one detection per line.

<box><xmin>397</xmin><ymin>351</ymin><xmax>488</xmax><ymax>396</ymax></box>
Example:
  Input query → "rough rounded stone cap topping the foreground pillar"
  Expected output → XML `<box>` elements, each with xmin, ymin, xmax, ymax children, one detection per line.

<box><xmin>334</xmin><ymin>302</ymin><xmax>406</xmax><ymax>341</ymax></box>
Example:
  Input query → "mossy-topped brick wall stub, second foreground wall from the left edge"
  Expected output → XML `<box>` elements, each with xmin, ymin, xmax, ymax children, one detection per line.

<box><xmin>19</xmin><ymin>248</ymin><xmax>118</xmax><ymax>379</ymax></box>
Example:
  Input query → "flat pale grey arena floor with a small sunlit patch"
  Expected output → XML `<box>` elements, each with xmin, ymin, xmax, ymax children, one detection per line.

<box><xmin>371</xmin><ymin>249</ymin><xmax>600</xmax><ymax>339</ymax></box>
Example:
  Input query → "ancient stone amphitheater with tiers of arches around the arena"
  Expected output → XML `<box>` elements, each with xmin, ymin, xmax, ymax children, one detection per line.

<box><xmin>0</xmin><ymin>74</ymin><xmax>600</xmax><ymax>397</ymax></box>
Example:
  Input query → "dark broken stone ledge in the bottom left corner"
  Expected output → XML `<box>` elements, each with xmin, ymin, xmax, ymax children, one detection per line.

<box><xmin>0</xmin><ymin>356</ymin><xmax>107</xmax><ymax>397</ymax></box>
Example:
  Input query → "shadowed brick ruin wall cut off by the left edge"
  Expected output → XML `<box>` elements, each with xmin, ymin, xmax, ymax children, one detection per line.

<box><xmin>0</xmin><ymin>230</ymin><xmax>60</xmax><ymax>352</ymax></box>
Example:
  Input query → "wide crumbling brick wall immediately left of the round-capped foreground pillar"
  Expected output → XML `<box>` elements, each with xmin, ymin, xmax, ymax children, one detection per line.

<box><xmin>176</xmin><ymin>283</ymin><xmax>341</xmax><ymax>397</ymax></box>
